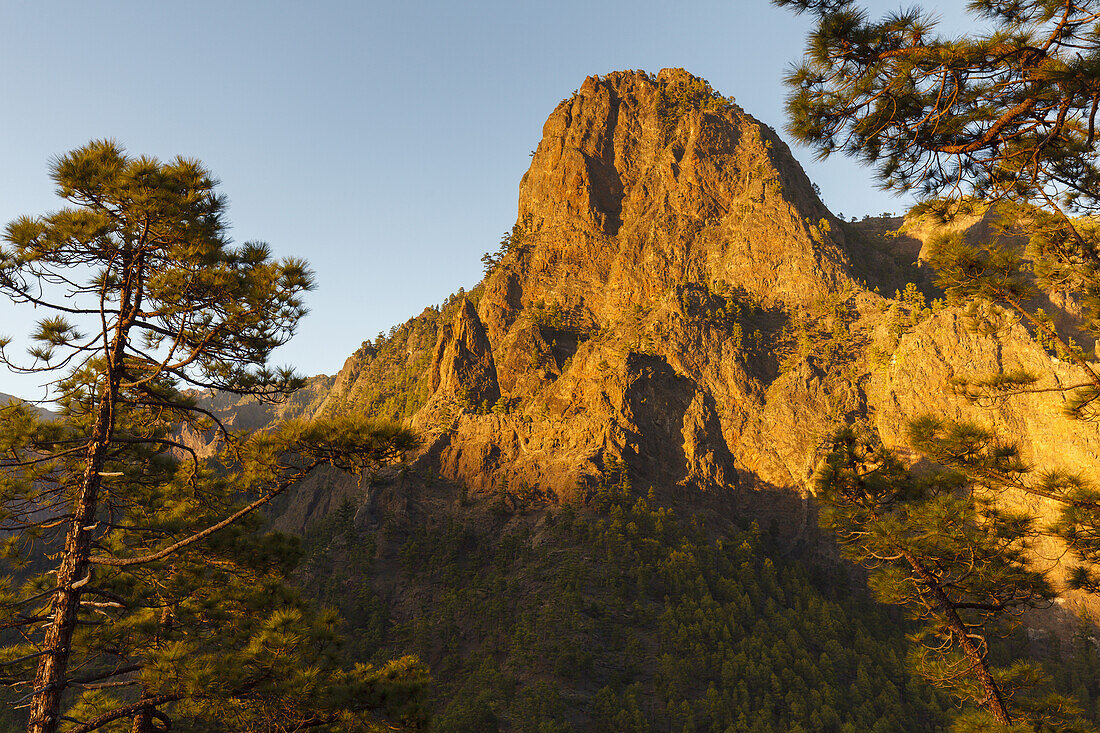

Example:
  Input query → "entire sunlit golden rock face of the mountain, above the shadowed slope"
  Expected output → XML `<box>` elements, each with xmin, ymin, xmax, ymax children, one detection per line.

<box><xmin>281</xmin><ymin>69</ymin><xmax>1100</xmax><ymax>519</ymax></box>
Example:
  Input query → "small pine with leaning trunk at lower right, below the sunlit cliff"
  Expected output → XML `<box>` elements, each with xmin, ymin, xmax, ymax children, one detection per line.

<box><xmin>817</xmin><ymin>423</ymin><xmax>1095</xmax><ymax>731</ymax></box>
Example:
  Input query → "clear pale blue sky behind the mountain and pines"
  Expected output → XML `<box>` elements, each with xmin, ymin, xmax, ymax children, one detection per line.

<box><xmin>0</xmin><ymin>0</ymin><xmax>961</xmax><ymax>397</ymax></box>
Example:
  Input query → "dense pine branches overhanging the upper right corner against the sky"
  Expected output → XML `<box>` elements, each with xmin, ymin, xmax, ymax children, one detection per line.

<box><xmin>774</xmin><ymin>0</ymin><xmax>1100</xmax><ymax>208</ymax></box>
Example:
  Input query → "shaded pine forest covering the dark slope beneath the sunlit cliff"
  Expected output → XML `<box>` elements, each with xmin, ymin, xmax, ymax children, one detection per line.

<box><xmin>301</xmin><ymin>466</ymin><xmax>950</xmax><ymax>733</ymax></box>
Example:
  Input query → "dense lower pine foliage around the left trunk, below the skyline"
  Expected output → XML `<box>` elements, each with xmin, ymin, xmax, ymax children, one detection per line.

<box><xmin>0</xmin><ymin>376</ymin><xmax>427</xmax><ymax>730</ymax></box>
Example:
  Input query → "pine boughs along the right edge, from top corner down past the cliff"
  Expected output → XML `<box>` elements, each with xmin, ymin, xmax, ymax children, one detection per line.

<box><xmin>773</xmin><ymin>0</ymin><xmax>1100</xmax><ymax>717</ymax></box>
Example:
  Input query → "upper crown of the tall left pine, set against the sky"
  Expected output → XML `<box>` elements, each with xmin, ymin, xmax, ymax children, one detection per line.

<box><xmin>0</xmin><ymin>141</ymin><xmax>312</xmax><ymax>395</ymax></box>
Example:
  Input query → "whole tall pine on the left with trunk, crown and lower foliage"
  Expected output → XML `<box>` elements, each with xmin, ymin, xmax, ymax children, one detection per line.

<box><xmin>0</xmin><ymin>141</ymin><xmax>426</xmax><ymax>733</ymax></box>
